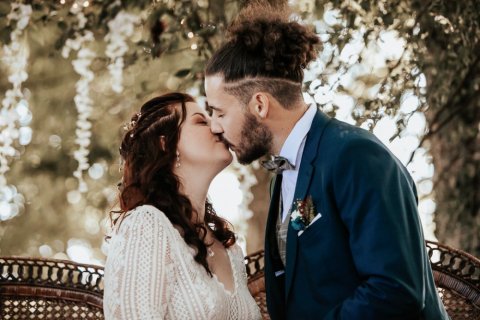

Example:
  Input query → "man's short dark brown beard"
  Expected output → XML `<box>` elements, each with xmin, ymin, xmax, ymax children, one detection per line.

<box><xmin>235</xmin><ymin>112</ymin><xmax>273</xmax><ymax>164</ymax></box>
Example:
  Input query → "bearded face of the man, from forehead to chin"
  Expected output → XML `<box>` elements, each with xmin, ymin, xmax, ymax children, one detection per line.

<box><xmin>205</xmin><ymin>75</ymin><xmax>273</xmax><ymax>164</ymax></box>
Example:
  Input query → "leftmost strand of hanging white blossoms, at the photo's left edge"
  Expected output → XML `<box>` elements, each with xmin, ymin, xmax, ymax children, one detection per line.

<box><xmin>0</xmin><ymin>3</ymin><xmax>32</xmax><ymax>220</ymax></box>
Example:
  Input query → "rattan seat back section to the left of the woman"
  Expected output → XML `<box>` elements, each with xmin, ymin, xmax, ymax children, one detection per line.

<box><xmin>0</xmin><ymin>257</ymin><xmax>103</xmax><ymax>320</ymax></box>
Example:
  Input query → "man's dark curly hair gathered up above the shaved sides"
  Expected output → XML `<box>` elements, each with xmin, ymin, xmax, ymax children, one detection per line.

<box><xmin>206</xmin><ymin>2</ymin><xmax>320</xmax><ymax>83</ymax></box>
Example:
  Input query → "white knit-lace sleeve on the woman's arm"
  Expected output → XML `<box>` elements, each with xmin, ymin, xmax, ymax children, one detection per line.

<box><xmin>110</xmin><ymin>206</ymin><xmax>171</xmax><ymax>319</ymax></box>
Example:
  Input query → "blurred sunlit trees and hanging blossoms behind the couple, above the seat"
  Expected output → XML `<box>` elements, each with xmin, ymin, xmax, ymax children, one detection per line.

<box><xmin>0</xmin><ymin>0</ymin><xmax>480</xmax><ymax>264</ymax></box>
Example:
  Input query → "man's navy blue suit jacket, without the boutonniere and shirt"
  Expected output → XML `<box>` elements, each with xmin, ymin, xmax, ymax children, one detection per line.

<box><xmin>265</xmin><ymin>111</ymin><xmax>448</xmax><ymax>320</ymax></box>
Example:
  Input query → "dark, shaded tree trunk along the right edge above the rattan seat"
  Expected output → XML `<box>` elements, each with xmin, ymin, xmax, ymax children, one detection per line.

<box><xmin>420</xmin><ymin>1</ymin><xmax>480</xmax><ymax>256</ymax></box>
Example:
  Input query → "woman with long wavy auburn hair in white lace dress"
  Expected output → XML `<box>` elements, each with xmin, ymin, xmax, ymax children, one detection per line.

<box><xmin>104</xmin><ymin>93</ymin><xmax>261</xmax><ymax>319</ymax></box>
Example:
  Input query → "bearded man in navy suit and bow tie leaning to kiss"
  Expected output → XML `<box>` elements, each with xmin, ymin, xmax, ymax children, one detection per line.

<box><xmin>205</xmin><ymin>3</ymin><xmax>448</xmax><ymax>320</ymax></box>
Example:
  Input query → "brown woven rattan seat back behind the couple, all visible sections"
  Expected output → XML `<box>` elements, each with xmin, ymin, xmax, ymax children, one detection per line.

<box><xmin>0</xmin><ymin>241</ymin><xmax>480</xmax><ymax>320</ymax></box>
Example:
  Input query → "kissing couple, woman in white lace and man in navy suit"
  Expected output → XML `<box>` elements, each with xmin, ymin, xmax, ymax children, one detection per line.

<box><xmin>104</xmin><ymin>5</ymin><xmax>448</xmax><ymax>320</ymax></box>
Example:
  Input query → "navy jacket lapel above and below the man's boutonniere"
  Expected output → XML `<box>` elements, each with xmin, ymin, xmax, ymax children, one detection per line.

<box><xmin>285</xmin><ymin>111</ymin><xmax>330</xmax><ymax>301</ymax></box>
